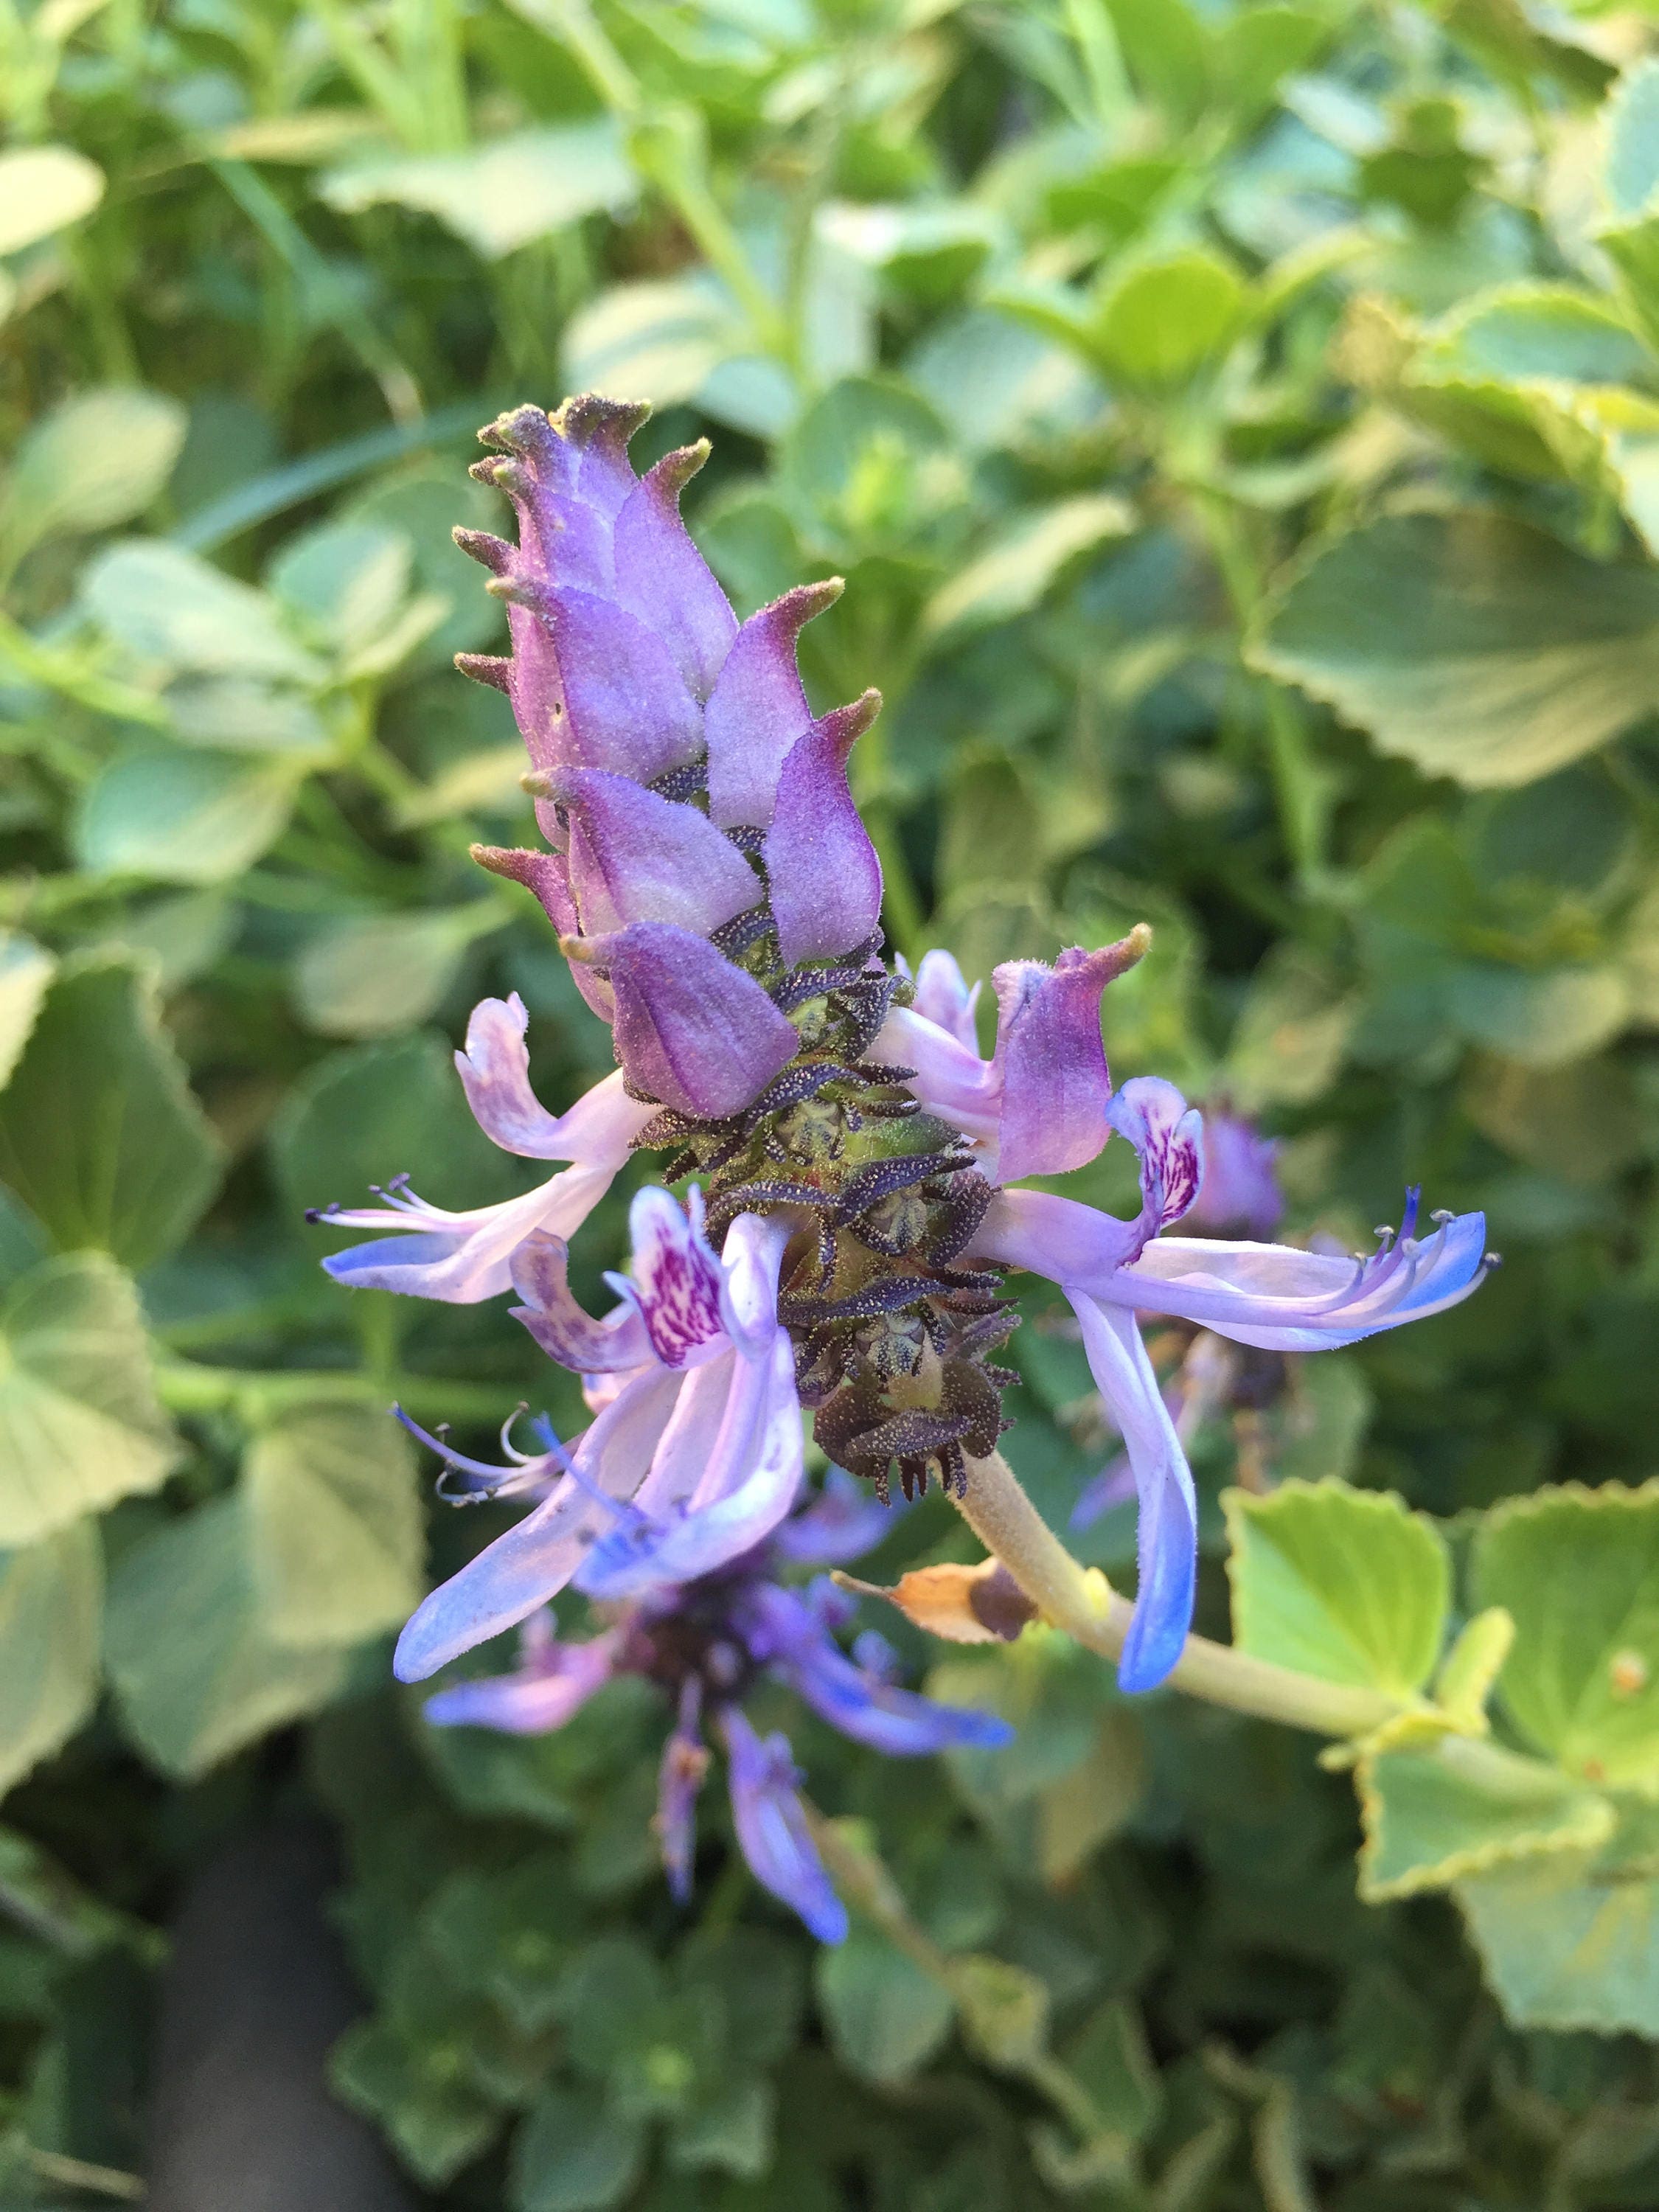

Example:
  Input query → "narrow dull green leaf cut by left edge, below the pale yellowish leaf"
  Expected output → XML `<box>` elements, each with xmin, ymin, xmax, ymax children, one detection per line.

<box><xmin>0</xmin><ymin>1520</ymin><xmax>104</xmax><ymax>1790</ymax></box>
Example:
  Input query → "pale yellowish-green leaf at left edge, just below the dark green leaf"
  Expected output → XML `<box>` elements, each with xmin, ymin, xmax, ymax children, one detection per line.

<box><xmin>0</xmin><ymin>1252</ymin><xmax>179</xmax><ymax>1546</ymax></box>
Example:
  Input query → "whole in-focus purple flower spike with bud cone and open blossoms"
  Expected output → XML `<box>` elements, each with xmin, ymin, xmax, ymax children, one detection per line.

<box><xmin>310</xmin><ymin>398</ymin><xmax>1486</xmax><ymax>1843</ymax></box>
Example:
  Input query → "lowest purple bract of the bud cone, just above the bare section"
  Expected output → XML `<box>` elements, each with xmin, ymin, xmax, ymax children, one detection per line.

<box><xmin>575</xmin><ymin>922</ymin><xmax>801</xmax><ymax>1119</ymax></box>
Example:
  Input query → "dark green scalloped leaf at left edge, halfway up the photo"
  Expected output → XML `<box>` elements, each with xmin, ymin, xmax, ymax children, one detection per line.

<box><xmin>0</xmin><ymin>960</ymin><xmax>223</xmax><ymax>1267</ymax></box>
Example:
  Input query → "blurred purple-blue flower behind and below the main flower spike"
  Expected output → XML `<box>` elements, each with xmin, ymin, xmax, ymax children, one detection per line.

<box><xmin>427</xmin><ymin>1469</ymin><xmax>1011</xmax><ymax>1942</ymax></box>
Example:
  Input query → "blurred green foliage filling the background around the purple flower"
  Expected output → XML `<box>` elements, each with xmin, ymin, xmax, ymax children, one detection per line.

<box><xmin>0</xmin><ymin>0</ymin><xmax>1659</xmax><ymax>2212</ymax></box>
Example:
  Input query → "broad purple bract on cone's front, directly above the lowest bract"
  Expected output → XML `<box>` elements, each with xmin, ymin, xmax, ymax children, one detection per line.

<box><xmin>546</xmin><ymin>768</ymin><xmax>763</xmax><ymax>938</ymax></box>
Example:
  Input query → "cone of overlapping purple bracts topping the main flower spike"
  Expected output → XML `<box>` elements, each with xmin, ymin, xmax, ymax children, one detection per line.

<box><xmin>456</xmin><ymin>398</ymin><xmax>880</xmax><ymax>1119</ymax></box>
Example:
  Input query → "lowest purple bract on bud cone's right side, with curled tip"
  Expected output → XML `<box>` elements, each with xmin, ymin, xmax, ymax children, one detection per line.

<box><xmin>765</xmin><ymin>690</ymin><xmax>880</xmax><ymax>967</ymax></box>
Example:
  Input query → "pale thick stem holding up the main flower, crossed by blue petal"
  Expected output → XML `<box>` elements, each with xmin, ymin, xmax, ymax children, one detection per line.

<box><xmin>956</xmin><ymin>1451</ymin><xmax>1400</xmax><ymax>1736</ymax></box>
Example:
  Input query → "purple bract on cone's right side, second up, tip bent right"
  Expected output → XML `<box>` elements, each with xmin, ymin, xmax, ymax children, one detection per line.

<box><xmin>706</xmin><ymin>577</ymin><xmax>845</xmax><ymax>830</ymax></box>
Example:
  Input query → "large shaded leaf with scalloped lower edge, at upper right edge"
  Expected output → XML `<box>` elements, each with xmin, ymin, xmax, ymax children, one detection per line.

<box><xmin>1250</xmin><ymin>511</ymin><xmax>1659</xmax><ymax>787</ymax></box>
